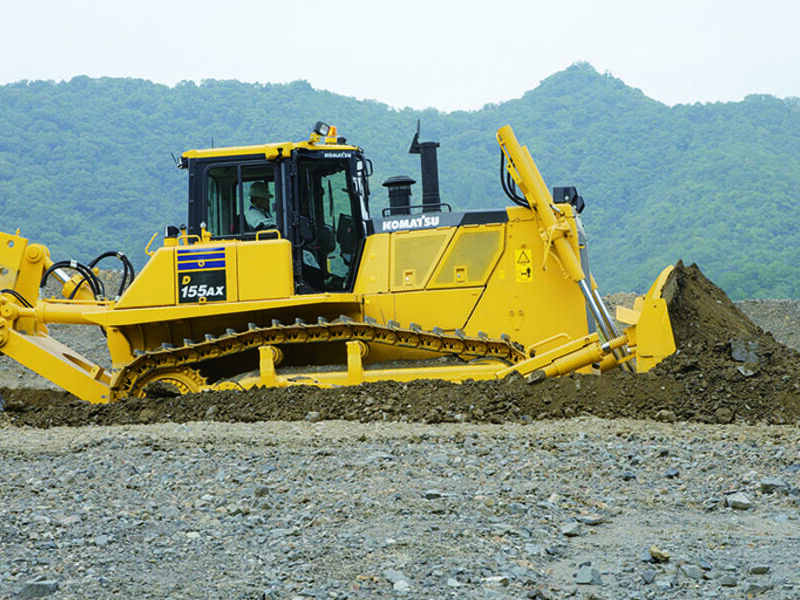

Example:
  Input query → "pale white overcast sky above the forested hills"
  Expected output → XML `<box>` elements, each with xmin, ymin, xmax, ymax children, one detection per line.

<box><xmin>0</xmin><ymin>0</ymin><xmax>800</xmax><ymax>111</ymax></box>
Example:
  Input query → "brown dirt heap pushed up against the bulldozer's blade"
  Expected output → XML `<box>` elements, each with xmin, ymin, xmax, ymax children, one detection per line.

<box><xmin>651</xmin><ymin>263</ymin><xmax>800</xmax><ymax>423</ymax></box>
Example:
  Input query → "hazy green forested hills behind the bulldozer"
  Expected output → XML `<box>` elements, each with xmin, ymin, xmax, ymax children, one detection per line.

<box><xmin>0</xmin><ymin>64</ymin><xmax>800</xmax><ymax>299</ymax></box>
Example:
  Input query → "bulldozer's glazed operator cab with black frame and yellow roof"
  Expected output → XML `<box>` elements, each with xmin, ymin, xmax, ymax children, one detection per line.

<box><xmin>180</xmin><ymin>135</ymin><xmax>369</xmax><ymax>294</ymax></box>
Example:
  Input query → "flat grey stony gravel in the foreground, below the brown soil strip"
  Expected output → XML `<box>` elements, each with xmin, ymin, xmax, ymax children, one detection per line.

<box><xmin>0</xmin><ymin>417</ymin><xmax>800</xmax><ymax>600</ymax></box>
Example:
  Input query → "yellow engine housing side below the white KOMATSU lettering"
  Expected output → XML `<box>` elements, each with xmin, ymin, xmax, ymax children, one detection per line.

<box><xmin>356</xmin><ymin>206</ymin><xmax>589</xmax><ymax>350</ymax></box>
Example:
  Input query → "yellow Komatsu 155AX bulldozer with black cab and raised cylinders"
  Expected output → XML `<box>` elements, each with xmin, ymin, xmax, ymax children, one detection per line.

<box><xmin>0</xmin><ymin>122</ymin><xmax>675</xmax><ymax>402</ymax></box>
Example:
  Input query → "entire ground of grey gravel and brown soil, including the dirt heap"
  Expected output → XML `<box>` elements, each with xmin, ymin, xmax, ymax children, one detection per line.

<box><xmin>0</xmin><ymin>269</ymin><xmax>800</xmax><ymax>600</ymax></box>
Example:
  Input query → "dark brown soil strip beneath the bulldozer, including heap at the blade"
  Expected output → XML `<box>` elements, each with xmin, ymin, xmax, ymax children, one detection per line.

<box><xmin>0</xmin><ymin>263</ymin><xmax>800</xmax><ymax>427</ymax></box>
